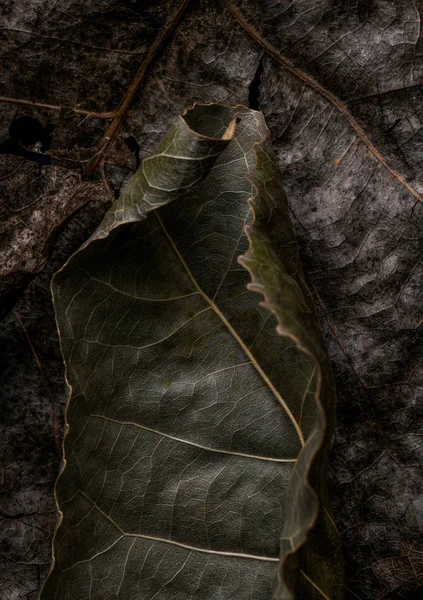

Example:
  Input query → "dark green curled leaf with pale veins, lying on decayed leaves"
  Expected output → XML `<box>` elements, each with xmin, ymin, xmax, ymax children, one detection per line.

<box><xmin>41</xmin><ymin>105</ymin><xmax>342</xmax><ymax>600</ymax></box>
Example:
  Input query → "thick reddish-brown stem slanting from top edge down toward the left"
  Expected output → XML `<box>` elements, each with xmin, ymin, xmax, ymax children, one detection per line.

<box><xmin>85</xmin><ymin>0</ymin><xmax>190</xmax><ymax>179</ymax></box>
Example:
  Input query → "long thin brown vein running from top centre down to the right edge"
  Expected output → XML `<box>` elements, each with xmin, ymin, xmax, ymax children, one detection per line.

<box><xmin>222</xmin><ymin>0</ymin><xmax>423</xmax><ymax>202</ymax></box>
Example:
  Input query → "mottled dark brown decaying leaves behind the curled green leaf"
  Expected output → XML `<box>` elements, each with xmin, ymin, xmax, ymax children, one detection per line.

<box><xmin>0</xmin><ymin>0</ymin><xmax>423</xmax><ymax>600</ymax></box>
